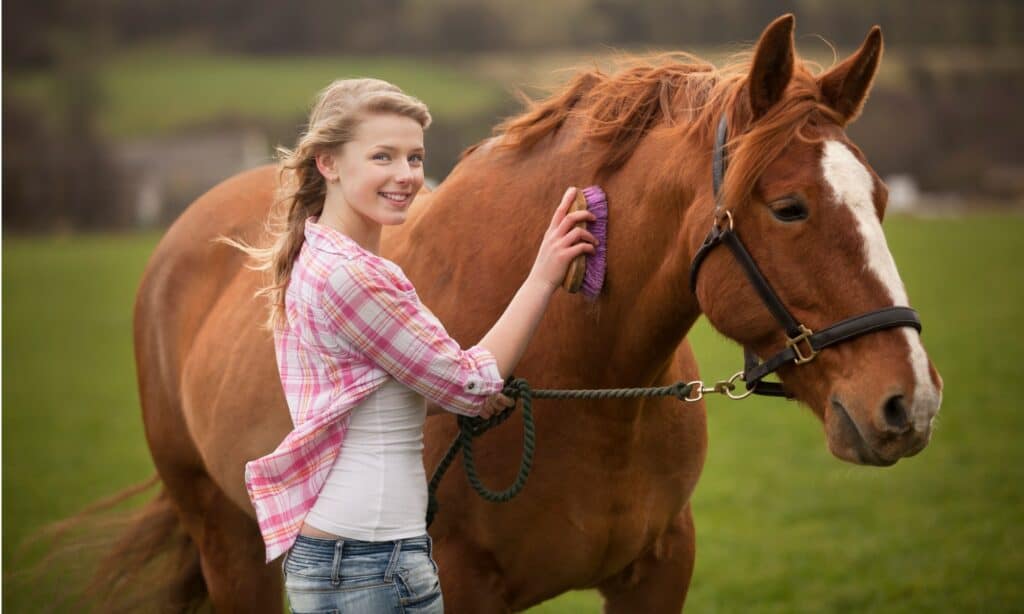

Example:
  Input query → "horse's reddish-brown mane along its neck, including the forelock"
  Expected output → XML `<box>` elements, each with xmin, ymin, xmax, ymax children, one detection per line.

<box><xmin>483</xmin><ymin>51</ymin><xmax>844</xmax><ymax>202</ymax></box>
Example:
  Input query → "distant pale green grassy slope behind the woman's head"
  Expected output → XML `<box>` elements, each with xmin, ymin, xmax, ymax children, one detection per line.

<box><xmin>4</xmin><ymin>46</ymin><xmax>507</xmax><ymax>138</ymax></box>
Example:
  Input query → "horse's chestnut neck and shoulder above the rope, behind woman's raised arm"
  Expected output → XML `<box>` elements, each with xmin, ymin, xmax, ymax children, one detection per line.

<box><xmin>385</xmin><ymin>126</ymin><xmax>700</xmax><ymax>386</ymax></box>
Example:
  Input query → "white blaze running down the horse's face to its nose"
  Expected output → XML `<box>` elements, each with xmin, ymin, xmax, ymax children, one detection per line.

<box><xmin>821</xmin><ymin>140</ymin><xmax>942</xmax><ymax>432</ymax></box>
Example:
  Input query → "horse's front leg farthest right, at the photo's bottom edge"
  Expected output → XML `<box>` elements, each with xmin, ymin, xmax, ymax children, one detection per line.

<box><xmin>598</xmin><ymin>503</ymin><xmax>695</xmax><ymax>614</ymax></box>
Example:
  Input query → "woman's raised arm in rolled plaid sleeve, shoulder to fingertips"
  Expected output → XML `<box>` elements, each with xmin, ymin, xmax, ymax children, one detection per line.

<box><xmin>321</xmin><ymin>188</ymin><xmax>594</xmax><ymax>415</ymax></box>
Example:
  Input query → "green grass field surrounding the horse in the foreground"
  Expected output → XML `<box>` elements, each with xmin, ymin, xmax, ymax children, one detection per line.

<box><xmin>2</xmin><ymin>214</ymin><xmax>1024</xmax><ymax>614</ymax></box>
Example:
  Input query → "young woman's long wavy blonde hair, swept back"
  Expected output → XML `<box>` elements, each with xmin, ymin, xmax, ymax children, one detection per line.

<box><xmin>216</xmin><ymin>79</ymin><xmax>430</xmax><ymax>330</ymax></box>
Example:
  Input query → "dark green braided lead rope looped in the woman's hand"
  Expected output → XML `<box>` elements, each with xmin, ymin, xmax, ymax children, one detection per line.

<box><xmin>427</xmin><ymin>376</ymin><xmax>693</xmax><ymax>527</ymax></box>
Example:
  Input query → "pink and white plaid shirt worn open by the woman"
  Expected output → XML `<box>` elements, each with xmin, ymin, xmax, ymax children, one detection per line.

<box><xmin>246</xmin><ymin>217</ymin><xmax>504</xmax><ymax>562</ymax></box>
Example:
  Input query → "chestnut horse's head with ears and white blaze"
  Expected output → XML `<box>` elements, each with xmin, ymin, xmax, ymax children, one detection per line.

<box><xmin>690</xmin><ymin>15</ymin><xmax>942</xmax><ymax>465</ymax></box>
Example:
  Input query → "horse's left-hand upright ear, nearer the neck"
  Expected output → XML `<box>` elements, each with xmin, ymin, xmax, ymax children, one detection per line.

<box><xmin>748</xmin><ymin>13</ymin><xmax>797</xmax><ymax>121</ymax></box>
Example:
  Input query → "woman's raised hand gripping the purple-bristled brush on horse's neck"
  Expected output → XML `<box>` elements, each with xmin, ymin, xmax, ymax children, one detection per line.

<box><xmin>528</xmin><ymin>187</ymin><xmax>597</xmax><ymax>290</ymax></box>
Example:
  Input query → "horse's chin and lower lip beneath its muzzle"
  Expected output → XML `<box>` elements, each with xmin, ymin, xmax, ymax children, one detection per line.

<box><xmin>824</xmin><ymin>399</ymin><xmax>931</xmax><ymax>467</ymax></box>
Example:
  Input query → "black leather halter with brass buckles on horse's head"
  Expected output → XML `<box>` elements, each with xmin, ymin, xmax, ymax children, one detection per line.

<box><xmin>690</xmin><ymin>116</ymin><xmax>921</xmax><ymax>396</ymax></box>
